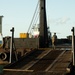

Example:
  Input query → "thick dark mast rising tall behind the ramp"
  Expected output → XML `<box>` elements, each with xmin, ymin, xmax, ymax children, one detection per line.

<box><xmin>39</xmin><ymin>0</ymin><xmax>48</xmax><ymax>48</ymax></box>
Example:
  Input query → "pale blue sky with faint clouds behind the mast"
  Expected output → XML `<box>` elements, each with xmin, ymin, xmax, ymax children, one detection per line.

<box><xmin>0</xmin><ymin>0</ymin><xmax>75</xmax><ymax>38</ymax></box>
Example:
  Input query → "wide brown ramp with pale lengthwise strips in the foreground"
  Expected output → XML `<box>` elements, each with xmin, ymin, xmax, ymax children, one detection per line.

<box><xmin>3</xmin><ymin>48</ymin><xmax>72</xmax><ymax>75</ymax></box>
